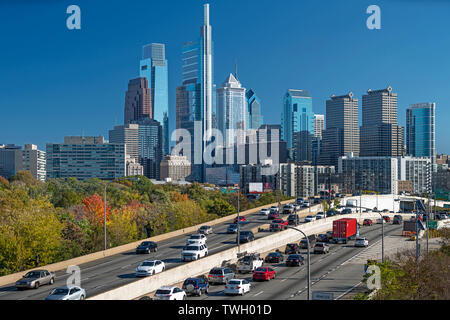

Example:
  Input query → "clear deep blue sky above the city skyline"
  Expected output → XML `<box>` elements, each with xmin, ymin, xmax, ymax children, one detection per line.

<box><xmin>0</xmin><ymin>0</ymin><xmax>450</xmax><ymax>153</ymax></box>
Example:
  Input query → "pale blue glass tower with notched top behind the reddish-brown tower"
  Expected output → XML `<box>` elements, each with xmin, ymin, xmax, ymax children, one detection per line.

<box><xmin>140</xmin><ymin>43</ymin><xmax>169</xmax><ymax>154</ymax></box>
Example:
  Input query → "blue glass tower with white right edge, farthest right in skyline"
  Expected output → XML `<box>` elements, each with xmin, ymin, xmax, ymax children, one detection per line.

<box><xmin>406</xmin><ymin>102</ymin><xmax>436</xmax><ymax>163</ymax></box>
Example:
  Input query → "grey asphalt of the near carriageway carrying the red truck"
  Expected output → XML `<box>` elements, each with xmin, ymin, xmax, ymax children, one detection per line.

<box><xmin>188</xmin><ymin>223</ymin><xmax>402</xmax><ymax>300</ymax></box>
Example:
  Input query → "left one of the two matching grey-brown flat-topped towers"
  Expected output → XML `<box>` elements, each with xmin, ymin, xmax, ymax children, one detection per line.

<box><xmin>319</xmin><ymin>92</ymin><xmax>359</xmax><ymax>166</ymax></box>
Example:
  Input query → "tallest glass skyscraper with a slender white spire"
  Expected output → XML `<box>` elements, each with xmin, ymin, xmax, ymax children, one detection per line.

<box><xmin>176</xmin><ymin>4</ymin><xmax>216</xmax><ymax>182</ymax></box>
